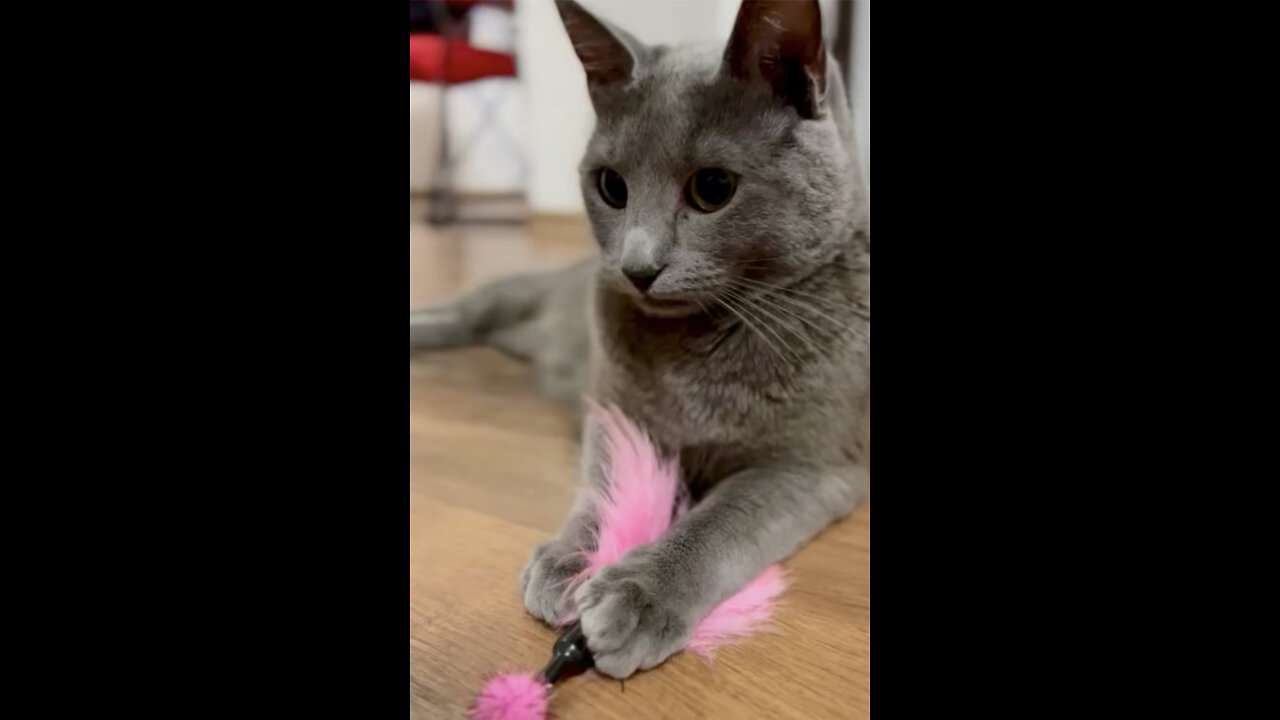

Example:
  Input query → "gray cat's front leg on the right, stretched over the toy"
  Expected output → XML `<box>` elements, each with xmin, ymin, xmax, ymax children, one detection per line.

<box><xmin>575</xmin><ymin>458</ymin><xmax>870</xmax><ymax>678</ymax></box>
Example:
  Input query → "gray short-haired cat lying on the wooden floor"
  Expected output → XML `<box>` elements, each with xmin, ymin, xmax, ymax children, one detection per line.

<box><xmin>410</xmin><ymin>0</ymin><xmax>872</xmax><ymax>678</ymax></box>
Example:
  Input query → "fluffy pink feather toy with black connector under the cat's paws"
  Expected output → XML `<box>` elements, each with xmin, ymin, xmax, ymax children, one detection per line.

<box><xmin>470</xmin><ymin>406</ymin><xmax>786</xmax><ymax>720</ymax></box>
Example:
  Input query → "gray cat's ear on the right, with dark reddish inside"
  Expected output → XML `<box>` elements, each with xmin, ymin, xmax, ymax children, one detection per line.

<box><xmin>724</xmin><ymin>0</ymin><xmax>827</xmax><ymax>119</ymax></box>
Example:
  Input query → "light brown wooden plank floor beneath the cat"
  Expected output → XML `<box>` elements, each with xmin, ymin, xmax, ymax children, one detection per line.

<box><xmin>408</xmin><ymin>206</ymin><xmax>872</xmax><ymax>720</ymax></box>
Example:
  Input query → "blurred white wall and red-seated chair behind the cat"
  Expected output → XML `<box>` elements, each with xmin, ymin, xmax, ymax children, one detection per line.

<box><xmin>408</xmin><ymin>0</ymin><xmax>870</xmax><ymax>227</ymax></box>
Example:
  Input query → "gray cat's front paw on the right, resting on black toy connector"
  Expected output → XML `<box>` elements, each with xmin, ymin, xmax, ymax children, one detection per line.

<box><xmin>573</xmin><ymin>553</ymin><xmax>692</xmax><ymax>679</ymax></box>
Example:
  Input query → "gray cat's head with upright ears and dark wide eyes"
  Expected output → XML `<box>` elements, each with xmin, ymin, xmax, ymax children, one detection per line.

<box><xmin>557</xmin><ymin>0</ymin><xmax>856</xmax><ymax>315</ymax></box>
